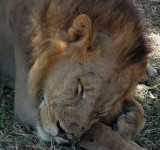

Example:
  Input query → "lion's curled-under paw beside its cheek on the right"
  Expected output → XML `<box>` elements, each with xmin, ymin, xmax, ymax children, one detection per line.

<box><xmin>100</xmin><ymin>98</ymin><xmax>145</xmax><ymax>139</ymax></box>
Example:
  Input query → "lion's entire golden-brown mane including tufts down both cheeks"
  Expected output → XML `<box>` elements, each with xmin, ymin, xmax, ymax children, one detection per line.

<box><xmin>29</xmin><ymin>0</ymin><xmax>149</xmax><ymax>103</ymax></box>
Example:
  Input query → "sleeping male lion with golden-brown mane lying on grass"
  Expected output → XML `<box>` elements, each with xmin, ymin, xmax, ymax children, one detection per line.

<box><xmin>0</xmin><ymin>0</ymin><xmax>152</xmax><ymax>148</ymax></box>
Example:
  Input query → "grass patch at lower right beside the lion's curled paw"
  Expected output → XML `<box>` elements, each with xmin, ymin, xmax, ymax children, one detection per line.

<box><xmin>135</xmin><ymin>82</ymin><xmax>160</xmax><ymax>150</ymax></box>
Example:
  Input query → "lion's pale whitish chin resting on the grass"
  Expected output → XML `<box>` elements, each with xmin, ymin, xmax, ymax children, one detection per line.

<box><xmin>37</xmin><ymin>124</ymin><xmax>70</xmax><ymax>144</ymax></box>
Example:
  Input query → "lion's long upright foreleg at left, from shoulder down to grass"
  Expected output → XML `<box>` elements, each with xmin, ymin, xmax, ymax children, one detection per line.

<box><xmin>9</xmin><ymin>0</ymin><xmax>38</xmax><ymax>125</ymax></box>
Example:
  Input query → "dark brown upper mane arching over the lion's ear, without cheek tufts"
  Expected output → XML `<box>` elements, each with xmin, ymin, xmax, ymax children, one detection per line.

<box><xmin>29</xmin><ymin>0</ymin><xmax>148</xmax><ymax>65</ymax></box>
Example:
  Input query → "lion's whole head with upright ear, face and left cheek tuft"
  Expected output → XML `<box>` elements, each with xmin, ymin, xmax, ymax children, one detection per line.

<box><xmin>29</xmin><ymin>15</ymin><xmax>141</xmax><ymax>143</ymax></box>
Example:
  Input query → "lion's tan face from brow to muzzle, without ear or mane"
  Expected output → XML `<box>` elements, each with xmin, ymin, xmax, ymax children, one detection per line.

<box><xmin>39</xmin><ymin>48</ymin><xmax>129</xmax><ymax>143</ymax></box>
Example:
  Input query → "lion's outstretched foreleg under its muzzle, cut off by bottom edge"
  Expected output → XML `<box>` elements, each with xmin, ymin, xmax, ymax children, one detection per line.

<box><xmin>78</xmin><ymin>123</ymin><xmax>145</xmax><ymax>150</ymax></box>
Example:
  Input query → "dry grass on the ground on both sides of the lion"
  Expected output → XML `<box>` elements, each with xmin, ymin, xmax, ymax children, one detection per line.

<box><xmin>0</xmin><ymin>0</ymin><xmax>160</xmax><ymax>150</ymax></box>
